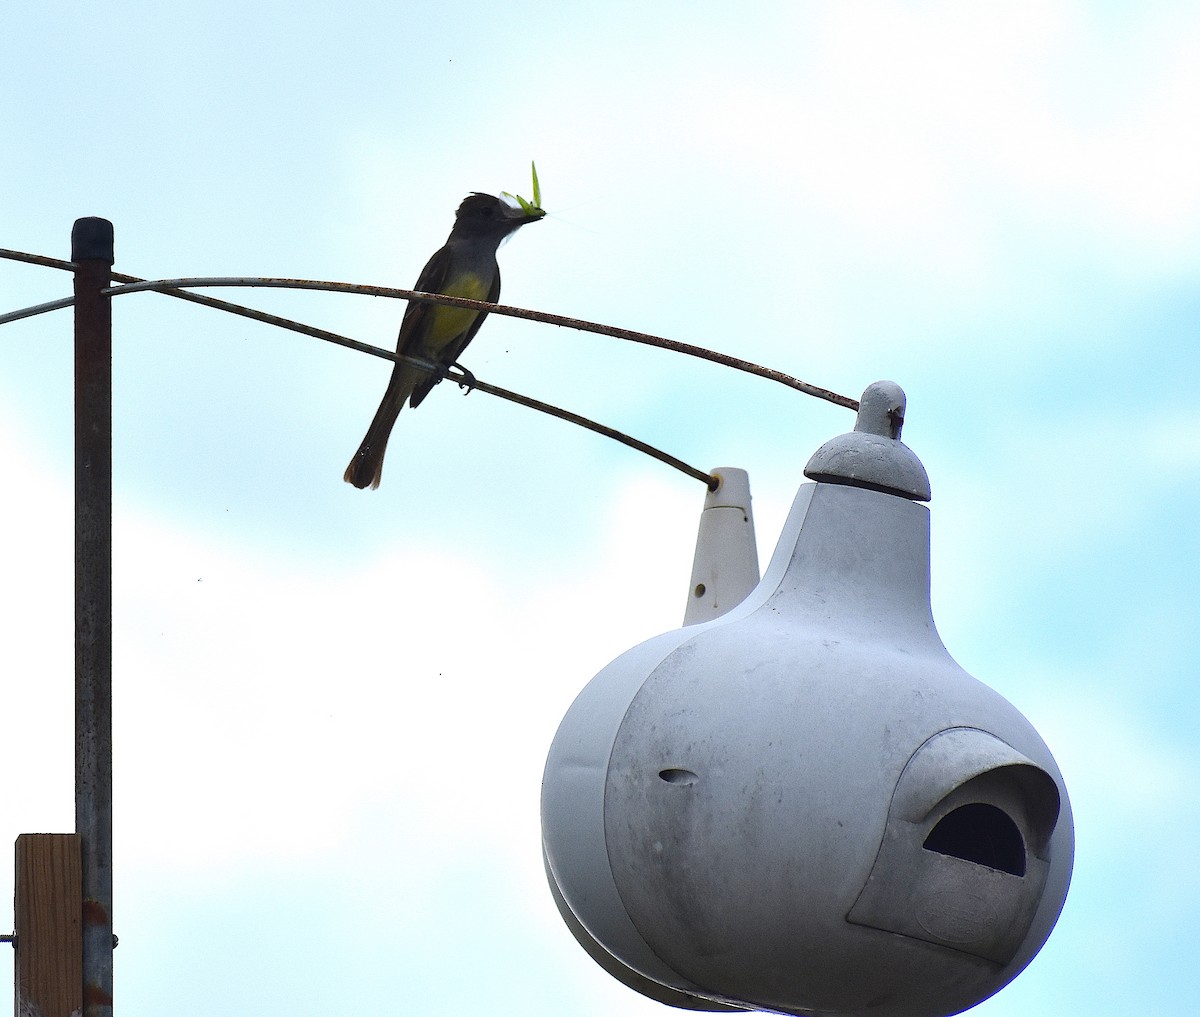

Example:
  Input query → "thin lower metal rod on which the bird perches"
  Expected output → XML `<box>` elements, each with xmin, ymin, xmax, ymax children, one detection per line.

<box><xmin>0</xmin><ymin>248</ymin><xmax>720</xmax><ymax>491</ymax></box>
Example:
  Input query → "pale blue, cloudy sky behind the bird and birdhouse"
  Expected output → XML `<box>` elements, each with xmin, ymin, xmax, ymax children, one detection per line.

<box><xmin>0</xmin><ymin>0</ymin><xmax>1200</xmax><ymax>1017</ymax></box>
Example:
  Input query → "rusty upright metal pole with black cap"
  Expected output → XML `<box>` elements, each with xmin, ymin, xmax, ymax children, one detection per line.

<box><xmin>71</xmin><ymin>218</ymin><xmax>113</xmax><ymax>1017</ymax></box>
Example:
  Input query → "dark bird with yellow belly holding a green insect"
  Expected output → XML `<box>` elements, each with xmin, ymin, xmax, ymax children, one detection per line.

<box><xmin>343</xmin><ymin>191</ymin><xmax>546</xmax><ymax>489</ymax></box>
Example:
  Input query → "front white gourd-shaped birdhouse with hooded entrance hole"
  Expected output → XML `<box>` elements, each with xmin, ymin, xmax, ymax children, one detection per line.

<box><xmin>541</xmin><ymin>383</ymin><xmax>1074</xmax><ymax>1017</ymax></box>
